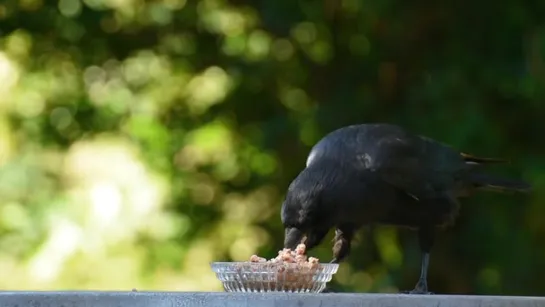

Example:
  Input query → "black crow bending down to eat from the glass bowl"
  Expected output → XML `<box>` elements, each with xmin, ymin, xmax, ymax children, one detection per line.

<box><xmin>281</xmin><ymin>124</ymin><xmax>530</xmax><ymax>294</ymax></box>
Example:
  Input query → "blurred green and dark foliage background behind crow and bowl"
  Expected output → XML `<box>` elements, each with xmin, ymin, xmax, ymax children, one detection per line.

<box><xmin>0</xmin><ymin>0</ymin><xmax>545</xmax><ymax>295</ymax></box>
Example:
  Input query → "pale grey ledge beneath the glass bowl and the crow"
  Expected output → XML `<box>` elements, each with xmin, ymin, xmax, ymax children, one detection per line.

<box><xmin>0</xmin><ymin>291</ymin><xmax>545</xmax><ymax>307</ymax></box>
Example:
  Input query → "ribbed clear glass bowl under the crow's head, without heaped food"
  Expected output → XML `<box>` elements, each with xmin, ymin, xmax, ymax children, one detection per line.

<box><xmin>211</xmin><ymin>262</ymin><xmax>339</xmax><ymax>293</ymax></box>
